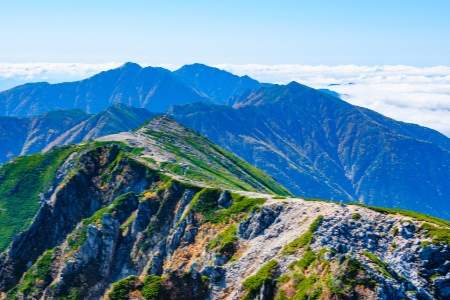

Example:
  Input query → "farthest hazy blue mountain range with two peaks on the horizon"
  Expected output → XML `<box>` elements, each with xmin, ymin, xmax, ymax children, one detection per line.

<box><xmin>0</xmin><ymin>63</ymin><xmax>260</xmax><ymax>117</ymax></box>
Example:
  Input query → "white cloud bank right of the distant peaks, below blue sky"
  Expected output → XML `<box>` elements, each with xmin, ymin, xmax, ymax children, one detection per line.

<box><xmin>217</xmin><ymin>65</ymin><xmax>450</xmax><ymax>136</ymax></box>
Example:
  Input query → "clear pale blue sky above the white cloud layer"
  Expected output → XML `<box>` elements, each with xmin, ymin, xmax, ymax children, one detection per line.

<box><xmin>0</xmin><ymin>0</ymin><xmax>450</xmax><ymax>66</ymax></box>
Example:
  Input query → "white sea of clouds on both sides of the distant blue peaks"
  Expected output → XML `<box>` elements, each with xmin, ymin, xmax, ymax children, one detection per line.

<box><xmin>0</xmin><ymin>63</ymin><xmax>450</xmax><ymax>136</ymax></box>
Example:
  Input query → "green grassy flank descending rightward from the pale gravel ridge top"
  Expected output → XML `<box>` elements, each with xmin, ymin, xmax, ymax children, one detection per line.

<box><xmin>141</xmin><ymin>120</ymin><xmax>291</xmax><ymax>195</ymax></box>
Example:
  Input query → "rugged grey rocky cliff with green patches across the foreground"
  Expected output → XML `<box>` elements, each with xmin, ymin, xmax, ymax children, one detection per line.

<box><xmin>2</xmin><ymin>181</ymin><xmax>450</xmax><ymax>299</ymax></box>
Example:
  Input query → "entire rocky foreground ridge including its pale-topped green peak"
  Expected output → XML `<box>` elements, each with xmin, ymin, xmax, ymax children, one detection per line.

<box><xmin>0</xmin><ymin>118</ymin><xmax>450</xmax><ymax>299</ymax></box>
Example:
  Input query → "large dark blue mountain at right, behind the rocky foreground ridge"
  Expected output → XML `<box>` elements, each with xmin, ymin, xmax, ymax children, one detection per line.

<box><xmin>172</xmin><ymin>82</ymin><xmax>450</xmax><ymax>219</ymax></box>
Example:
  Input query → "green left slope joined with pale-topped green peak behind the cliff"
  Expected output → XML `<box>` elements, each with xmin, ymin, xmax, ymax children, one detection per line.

<box><xmin>0</xmin><ymin>117</ymin><xmax>289</xmax><ymax>250</ymax></box>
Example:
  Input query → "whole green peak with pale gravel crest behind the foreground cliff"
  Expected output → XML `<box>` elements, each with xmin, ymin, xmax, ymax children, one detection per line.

<box><xmin>99</xmin><ymin>115</ymin><xmax>289</xmax><ymax>194</ymax></box>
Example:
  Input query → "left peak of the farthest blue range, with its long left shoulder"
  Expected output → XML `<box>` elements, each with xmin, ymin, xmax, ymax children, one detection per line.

<box><xmin>0</xmin><ymin>63</ymin><xmax>204</xmax><ymax>116</ymax></box>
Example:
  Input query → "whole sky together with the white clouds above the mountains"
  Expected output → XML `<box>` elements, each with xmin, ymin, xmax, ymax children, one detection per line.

<box><xmin>0</xmin><ymin>0</ymin><xmax>450</xmax><ymax>136</ymax></box>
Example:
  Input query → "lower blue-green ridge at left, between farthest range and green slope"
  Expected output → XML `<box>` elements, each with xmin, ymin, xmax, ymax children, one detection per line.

<box><xmin>0</xmin><ymin>104</ymin><xmax>154</xmax><ymax>163</ymax></box>
